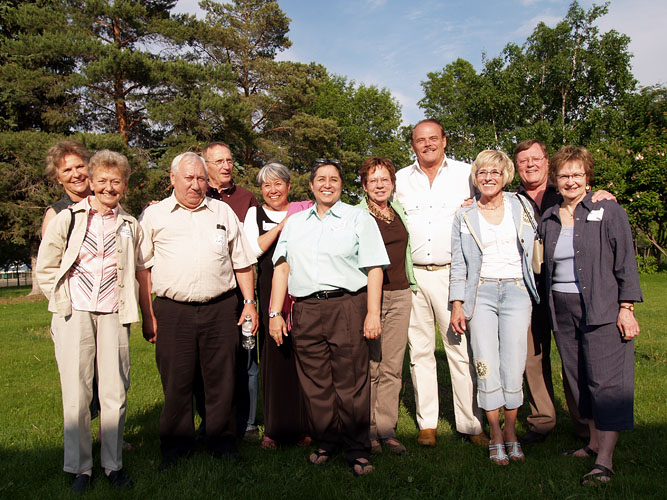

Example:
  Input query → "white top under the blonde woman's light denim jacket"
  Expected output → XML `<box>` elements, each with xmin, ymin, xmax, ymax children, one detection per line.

<box><xmin>479</xmin><ymin>200</ymin><xmax>523</xmax><ymax>278</ymax></box>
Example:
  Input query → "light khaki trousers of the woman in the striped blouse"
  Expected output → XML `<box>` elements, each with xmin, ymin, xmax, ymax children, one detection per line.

<box><xmin>51</xmin><ymin>310</ymin><xmax>130</xmax><ymax>474</ymax></box>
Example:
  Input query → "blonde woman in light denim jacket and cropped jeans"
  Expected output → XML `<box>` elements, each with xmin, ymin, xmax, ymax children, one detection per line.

<box><xmin>449</xmin><ymin>150</ymin><xmax>539</xmax><ymax>465</ymax></box>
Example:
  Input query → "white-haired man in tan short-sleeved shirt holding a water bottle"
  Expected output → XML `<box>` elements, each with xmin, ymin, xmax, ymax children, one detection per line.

<box><xmin>137</xmin><ymin>153</ymin><xmax>257</xmax><ymax>470</ymax></box>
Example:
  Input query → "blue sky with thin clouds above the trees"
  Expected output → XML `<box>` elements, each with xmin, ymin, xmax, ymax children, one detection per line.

<box><xmin>175</xmin><ymin>0</ymin><xmax>667</xmax><ymax>124</ymax></box>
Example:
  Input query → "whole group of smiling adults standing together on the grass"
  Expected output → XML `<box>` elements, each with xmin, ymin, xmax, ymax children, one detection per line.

<box><xmin>37</xmin><ymin>120</ymin><xmax>642</xmax><ymax>493</ymax></box>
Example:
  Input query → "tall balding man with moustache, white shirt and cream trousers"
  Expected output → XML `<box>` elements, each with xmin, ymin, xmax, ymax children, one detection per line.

<box><xmin>396</xmin><ymin>120</ymin><xmax>488</xmax><ymax>446</ymax></box>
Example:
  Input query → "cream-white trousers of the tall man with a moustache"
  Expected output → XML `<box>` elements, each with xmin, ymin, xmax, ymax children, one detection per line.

<box><xmin>408</xmin><ymin>268</ymin><xmax>483</xmax><ymax>434</ymax></box>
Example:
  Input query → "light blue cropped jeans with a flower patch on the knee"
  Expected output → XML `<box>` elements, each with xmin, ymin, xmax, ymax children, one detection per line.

<box><xmin>468</xmin><ymin>278</ymin><xmax>532</xmax><ymax>411</ymax></box>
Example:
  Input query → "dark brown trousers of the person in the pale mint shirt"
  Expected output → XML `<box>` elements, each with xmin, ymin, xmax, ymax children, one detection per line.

<box><xmin>291</xmin><ymin>292</ymin><xmax>370</xmax><ymax>462</ymax></box>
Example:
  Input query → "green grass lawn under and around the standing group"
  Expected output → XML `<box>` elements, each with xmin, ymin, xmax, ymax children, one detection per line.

<box><xmin>0</xmin><ymin>275</ymin><xmax>667</xmax><ymax>500</ymax></box>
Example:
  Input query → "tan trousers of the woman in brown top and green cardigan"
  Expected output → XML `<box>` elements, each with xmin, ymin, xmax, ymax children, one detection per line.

<box><xmin>368</xmin><ymin>288</ymin><xmax>412</xmax><ymax>439</ymax></box>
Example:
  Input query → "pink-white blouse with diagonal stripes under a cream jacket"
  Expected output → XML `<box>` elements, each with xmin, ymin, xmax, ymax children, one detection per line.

<box><xmin>68</xmin><ymin>197</ymin><xmax>118</xmax><ymax>313</ymax></box>
